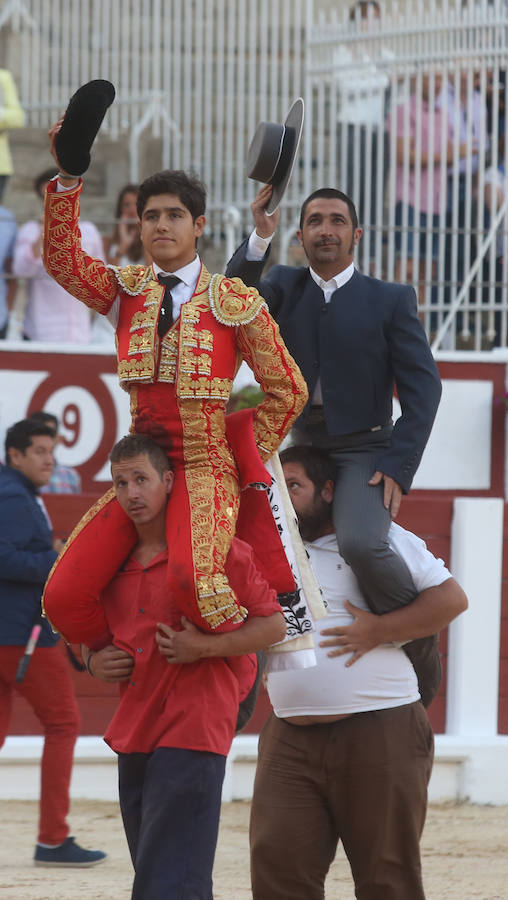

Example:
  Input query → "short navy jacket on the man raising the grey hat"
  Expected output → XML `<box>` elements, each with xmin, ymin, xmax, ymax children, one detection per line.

<box><xmin>226</xmin><ymin>241</ymin><xmax>441</xmax><ymax>492</ymax></box>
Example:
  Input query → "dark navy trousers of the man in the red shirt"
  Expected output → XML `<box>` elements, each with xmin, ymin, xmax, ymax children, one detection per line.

<box><xmin>118</xmin><ymin>747</ymin><xmax>226</xmax><ymax>900</ymax></box>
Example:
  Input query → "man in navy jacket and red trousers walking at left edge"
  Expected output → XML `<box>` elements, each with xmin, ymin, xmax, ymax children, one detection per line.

<box><xmin>0</xmin><ymin>419</ymin><xmax>106</xmax><ymax>867</ymax></box>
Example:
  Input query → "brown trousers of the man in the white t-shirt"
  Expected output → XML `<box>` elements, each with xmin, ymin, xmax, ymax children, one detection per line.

<box><xmin>250</xmin><ymin>701</ymin><xmax>434</xmax><ymax>900</ymax></box>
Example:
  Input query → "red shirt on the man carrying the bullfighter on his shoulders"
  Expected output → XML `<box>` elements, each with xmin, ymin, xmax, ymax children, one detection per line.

<box><xmin>101</xmin><ymin>539</ymin><xmax>281</xmax><ymax>756</ymax></box>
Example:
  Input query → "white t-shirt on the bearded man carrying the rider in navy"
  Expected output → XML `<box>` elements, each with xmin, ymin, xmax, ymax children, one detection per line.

<box><xmin>268</xmin><ymin>523</ymin><xmax>451</xmax><ymax>718</ymax></box>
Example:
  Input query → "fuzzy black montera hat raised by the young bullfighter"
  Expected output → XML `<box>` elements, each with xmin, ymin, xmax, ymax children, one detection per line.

<box><xmin>55</xmin><ymin>78</ymin><xmax>115</xmax><ymax>175</ymax></box>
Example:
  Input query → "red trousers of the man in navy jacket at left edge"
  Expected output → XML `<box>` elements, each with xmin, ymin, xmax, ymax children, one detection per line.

<box><xmin>0</xmin><ymin>644</ymin><xmax>80</xmax><ymax>845</ymax></box>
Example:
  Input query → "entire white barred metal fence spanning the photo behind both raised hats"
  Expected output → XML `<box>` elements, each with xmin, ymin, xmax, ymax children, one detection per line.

<box><xmin>0</xmin><ymin>0</ymin><xmax>508</xmax><ymax>349</ymax></box>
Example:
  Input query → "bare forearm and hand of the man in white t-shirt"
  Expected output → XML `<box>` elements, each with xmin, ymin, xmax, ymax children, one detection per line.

<box><xmin>319</xmin><ymin>578</ymin><xmax>467</xmax><ymax>665</ymax></box>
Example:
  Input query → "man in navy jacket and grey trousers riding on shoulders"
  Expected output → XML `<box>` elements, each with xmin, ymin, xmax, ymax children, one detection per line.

<box><xmin>227</xmin><ymin>185</ymin><xmax>441</xmax><ymax>705</ymax></box>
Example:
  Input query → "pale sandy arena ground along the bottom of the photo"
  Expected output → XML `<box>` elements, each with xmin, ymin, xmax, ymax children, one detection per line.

<box><xmin>0</xmin><ymin>801</ymin><xmax>508</xmax><ymax>900</ymax></box>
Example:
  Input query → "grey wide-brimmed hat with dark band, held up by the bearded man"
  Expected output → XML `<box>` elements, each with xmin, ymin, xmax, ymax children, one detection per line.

<box><xmin>247</xmin><ymin>97</ymin><xmax>303</xmax><ymax>215</ymax></box>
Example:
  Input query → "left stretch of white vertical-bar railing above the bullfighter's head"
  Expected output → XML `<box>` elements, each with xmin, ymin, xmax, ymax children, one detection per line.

<box><xmin>0</xmin><ymin>0</ymin><xmax>313</xmax><ymax>241</ymax></box>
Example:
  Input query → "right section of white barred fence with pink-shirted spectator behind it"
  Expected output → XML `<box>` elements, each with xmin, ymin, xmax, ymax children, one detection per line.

<box><xmin>306</xmin><ymin>0</ymin><xmax>508</xmax><ymax>349</ymax></box>
